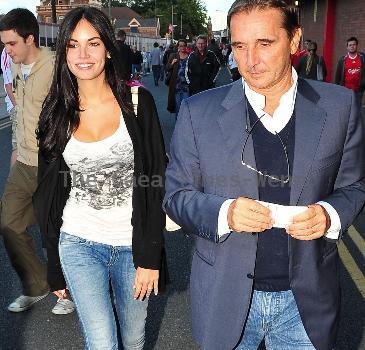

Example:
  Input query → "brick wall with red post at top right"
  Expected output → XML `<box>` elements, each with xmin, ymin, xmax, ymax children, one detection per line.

<box><xmin>299</xmin><ymin>0</ymin><xmax>365</xmax><ymax>82</ymax></box>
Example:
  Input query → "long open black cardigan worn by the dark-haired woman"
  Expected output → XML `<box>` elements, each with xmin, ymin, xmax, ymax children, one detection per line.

<box><xmin>33</xmin><ymin>88</ymin><xmax>167</xmax><ymax>291</ymax></box>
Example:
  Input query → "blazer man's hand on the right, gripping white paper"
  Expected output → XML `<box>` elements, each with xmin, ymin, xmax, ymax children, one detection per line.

<box><xmin>286</xmin><ymin>204</ymin><xmax>331</xmax><ymax>241</ymax></box>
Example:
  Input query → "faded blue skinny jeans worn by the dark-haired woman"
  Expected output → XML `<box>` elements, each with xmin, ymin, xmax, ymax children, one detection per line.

<box><xmin>59</xmin><ymin>232</ymin><xmax>148</xmax><ymax>350</ymax></box>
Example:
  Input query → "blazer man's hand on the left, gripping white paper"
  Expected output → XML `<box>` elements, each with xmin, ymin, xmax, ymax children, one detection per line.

<box><xmin>227</xmin><ymin>197</ymin><xmax>274</xmax><ymax>232</ymax></box>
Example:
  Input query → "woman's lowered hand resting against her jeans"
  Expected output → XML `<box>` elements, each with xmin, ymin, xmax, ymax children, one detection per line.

<box><xmin>133</xmin><ymin>267</ymin><xmax>159</xmax><ymax>301</ymax></box>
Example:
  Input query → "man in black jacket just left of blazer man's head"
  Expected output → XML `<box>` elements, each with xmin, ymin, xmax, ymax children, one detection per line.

<box><xmin>185</xmin><ymin>35</ymin><xmax>220</xmax><ymax>96</ymax></box>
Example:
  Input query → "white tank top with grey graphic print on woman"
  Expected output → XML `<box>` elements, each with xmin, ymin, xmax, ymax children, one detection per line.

<box><xmin>61</xmin><ymin>116</ymin><xmax>134</xmax><ymax>246</ymax></box>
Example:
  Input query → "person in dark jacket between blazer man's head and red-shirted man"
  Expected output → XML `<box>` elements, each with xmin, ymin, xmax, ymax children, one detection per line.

<box><xmin>296</xmin><ymin>41</ymin><xmax>327</xmax><ymax>81</ymax></box>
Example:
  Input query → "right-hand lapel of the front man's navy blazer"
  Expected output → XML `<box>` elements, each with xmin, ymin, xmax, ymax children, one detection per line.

<box><xmin>290</xmin><ymin>79</ymin><xmax>327</xmax><ymax>205</ymax></box>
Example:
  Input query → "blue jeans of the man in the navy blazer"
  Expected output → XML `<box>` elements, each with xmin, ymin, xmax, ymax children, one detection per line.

<box><xmin>235</xmin><ymin>290</ymin><xmax>314</xmax><ymax>350</ymax></box>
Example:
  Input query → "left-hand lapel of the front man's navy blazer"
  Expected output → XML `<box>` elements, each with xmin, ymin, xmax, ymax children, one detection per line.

<box><xmin>218</xmin><ymin>80</ymin><xmax>258</xmax><ymax>199</ymax></box>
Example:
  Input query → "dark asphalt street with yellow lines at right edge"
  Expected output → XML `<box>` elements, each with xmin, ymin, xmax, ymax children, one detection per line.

<box><xmin>0</xmin><ymin>71</ymin><xmax>365</xmax><ymax>350</ymax></box>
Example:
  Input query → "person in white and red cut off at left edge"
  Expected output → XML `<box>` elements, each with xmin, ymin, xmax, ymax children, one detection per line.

<box><xmin>1</xmin><ymin>48</ymin><xmax>16</xmax><ymax>167</ymax></box>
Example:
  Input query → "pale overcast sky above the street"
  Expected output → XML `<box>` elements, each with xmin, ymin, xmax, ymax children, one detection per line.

<box><xmin>0</xmin><ymin>0</ymin><xmax>233</xmax><ymax>30</ymax></box>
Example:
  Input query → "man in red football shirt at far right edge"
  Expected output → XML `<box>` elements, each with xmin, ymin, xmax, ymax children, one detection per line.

<box><xmin>335</xmin><ymin>37</ymin><xmax>365</xmax><ymax>107</ymax></box>
